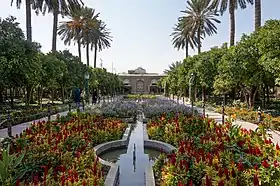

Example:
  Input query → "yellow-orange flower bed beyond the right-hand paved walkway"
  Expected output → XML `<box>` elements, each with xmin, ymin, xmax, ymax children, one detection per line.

<box><xmin>216</xmin><ymin>107</ymin><xmax>280</xmax><ymax>130</ymax></box>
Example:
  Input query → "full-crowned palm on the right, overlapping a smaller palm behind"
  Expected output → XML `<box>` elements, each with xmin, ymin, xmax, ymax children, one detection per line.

<box><xmin>181</xmin><ymin>0</ymin><xmax>220</xmax><ymax>53</ymax></box>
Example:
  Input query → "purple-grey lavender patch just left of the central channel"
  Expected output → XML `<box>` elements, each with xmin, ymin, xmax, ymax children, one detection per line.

<box><xmin>101</xmin><ymin>101</ymin><xmax>139</xmax><ymax>118</ymax></box>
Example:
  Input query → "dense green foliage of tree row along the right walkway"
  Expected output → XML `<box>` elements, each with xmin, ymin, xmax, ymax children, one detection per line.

<box><xmin>165</xmin><ymin>20</ymin><xmax>280</xmax><ymax>108</ymax></box>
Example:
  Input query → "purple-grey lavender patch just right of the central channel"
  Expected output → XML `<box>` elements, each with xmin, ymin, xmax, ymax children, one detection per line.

<box><xmin>143</xmin><ymin>99</ymin><xmax>191</xmax><ymax>118</ymax></box>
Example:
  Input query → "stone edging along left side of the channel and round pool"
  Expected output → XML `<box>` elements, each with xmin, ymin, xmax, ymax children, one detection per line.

<box><xmin>94</xmin><ymin>124</ymin><xmax>132</xmax><ymax>186</ymax></box>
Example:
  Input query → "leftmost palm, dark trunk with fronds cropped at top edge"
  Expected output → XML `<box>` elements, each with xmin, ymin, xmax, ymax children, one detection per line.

<box><xmin>11</xmin><ymin>0</ymin><xmax>34</xmax><ymax>41</ymax></box>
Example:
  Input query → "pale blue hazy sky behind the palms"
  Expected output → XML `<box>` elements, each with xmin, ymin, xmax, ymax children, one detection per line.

<box><xmin>0</xmin><ymin>0</ymin><xmax>280</xmax><ymax>73</ymax></box>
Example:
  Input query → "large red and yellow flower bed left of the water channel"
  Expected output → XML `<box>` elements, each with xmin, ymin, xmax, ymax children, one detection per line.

<box><xmin>0</xmin><ymin>114</ymin><xmax>126</xmax><ymax>186</ymax></box>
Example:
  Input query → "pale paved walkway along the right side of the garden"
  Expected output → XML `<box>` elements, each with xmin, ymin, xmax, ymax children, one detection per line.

<box><xmin>171</xmin><ymin>97</ymin><xmax>280</xmax><ymax>144</ymax></box>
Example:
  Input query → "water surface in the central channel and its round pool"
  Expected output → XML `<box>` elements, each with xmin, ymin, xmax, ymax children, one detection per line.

<box><xmin>100</xmin><ymin>115</ymin><xmax>160</xmax><ymax>186</ymax></box>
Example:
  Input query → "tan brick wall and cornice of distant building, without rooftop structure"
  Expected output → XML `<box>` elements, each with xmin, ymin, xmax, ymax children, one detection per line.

<box><xmin>119</xmin><ymin>74</ymin><xmax>164</xmax><ymax>94</ymax></box>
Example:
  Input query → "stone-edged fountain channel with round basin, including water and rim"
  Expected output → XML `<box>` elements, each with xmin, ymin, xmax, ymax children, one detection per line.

<box><xmin>95</xmin><ymin>101</ymin><xmax>175</xmax><ymax>186</ymax></box>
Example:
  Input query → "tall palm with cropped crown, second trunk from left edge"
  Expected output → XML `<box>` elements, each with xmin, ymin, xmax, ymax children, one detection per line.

<box><xmin>35</xmin><ymin>0</ymin><xmax>83</xmax><ymax>52</ymax></box>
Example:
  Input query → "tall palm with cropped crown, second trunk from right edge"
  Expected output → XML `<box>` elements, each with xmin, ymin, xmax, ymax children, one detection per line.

<box><xmin>213</xmin><ymin>0</ymin><xmax>254</xmax><ymax>46</ymax></box>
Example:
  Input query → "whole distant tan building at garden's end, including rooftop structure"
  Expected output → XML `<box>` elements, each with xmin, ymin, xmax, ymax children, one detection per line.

<box><xmin>118</xmin><ymin>67</ymin><xmax>167</xmax><ymax>94</ymax></box>
